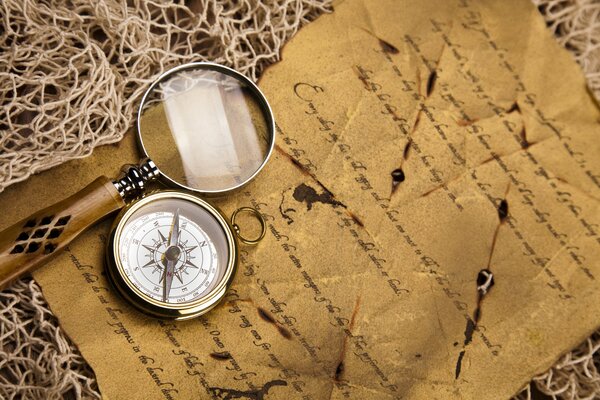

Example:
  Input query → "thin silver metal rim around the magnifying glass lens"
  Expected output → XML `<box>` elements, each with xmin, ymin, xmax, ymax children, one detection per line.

<box><xmin>136</xmin><ymin>61</ymin><xmax>275</xmax><ymax>195</ymax></box>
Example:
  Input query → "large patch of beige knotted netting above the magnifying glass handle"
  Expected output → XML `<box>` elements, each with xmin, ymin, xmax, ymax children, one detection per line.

<box><xmin>0</xmin><ymin>0</ymin><xmax>328</xmax><ymax>191</ymax></box>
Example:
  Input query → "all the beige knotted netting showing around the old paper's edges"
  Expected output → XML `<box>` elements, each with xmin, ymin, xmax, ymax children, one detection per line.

<box><xmin>0</xmin><ymin>0</ymin><xmax>600</xmax><ymax>399</ymax></box>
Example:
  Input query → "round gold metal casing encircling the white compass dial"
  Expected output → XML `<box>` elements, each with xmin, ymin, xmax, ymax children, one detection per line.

<box><xmin>106</xmin><ymin>190</ymin><xmax>238</xmax><ymax>320</ymax></box>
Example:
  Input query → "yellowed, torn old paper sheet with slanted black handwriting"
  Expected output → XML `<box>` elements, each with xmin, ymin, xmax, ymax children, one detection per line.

<box><xmin>0</xmin><ymin>0</ymin><xmax>600</xmax><ymax>399</ymax></box>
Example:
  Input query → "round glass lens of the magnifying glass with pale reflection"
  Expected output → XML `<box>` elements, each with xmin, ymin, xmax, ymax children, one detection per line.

<box><xmin>138</xmin><ymin>64</ymin><xmax>273</xmax><ymax>193</ymax></box>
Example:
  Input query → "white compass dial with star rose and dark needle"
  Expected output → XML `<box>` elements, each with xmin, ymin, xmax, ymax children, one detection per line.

<box><xmin>116</xmin><ymin>198</ymin><xmax>229</xmax><ymax>306</ymax></box>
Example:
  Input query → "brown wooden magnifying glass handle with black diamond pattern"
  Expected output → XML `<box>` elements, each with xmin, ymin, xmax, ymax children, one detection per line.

<box><xmin>0</xmin><ymin>176</ymin><xmax>125</xmax><ymax>289</ymax></box>
